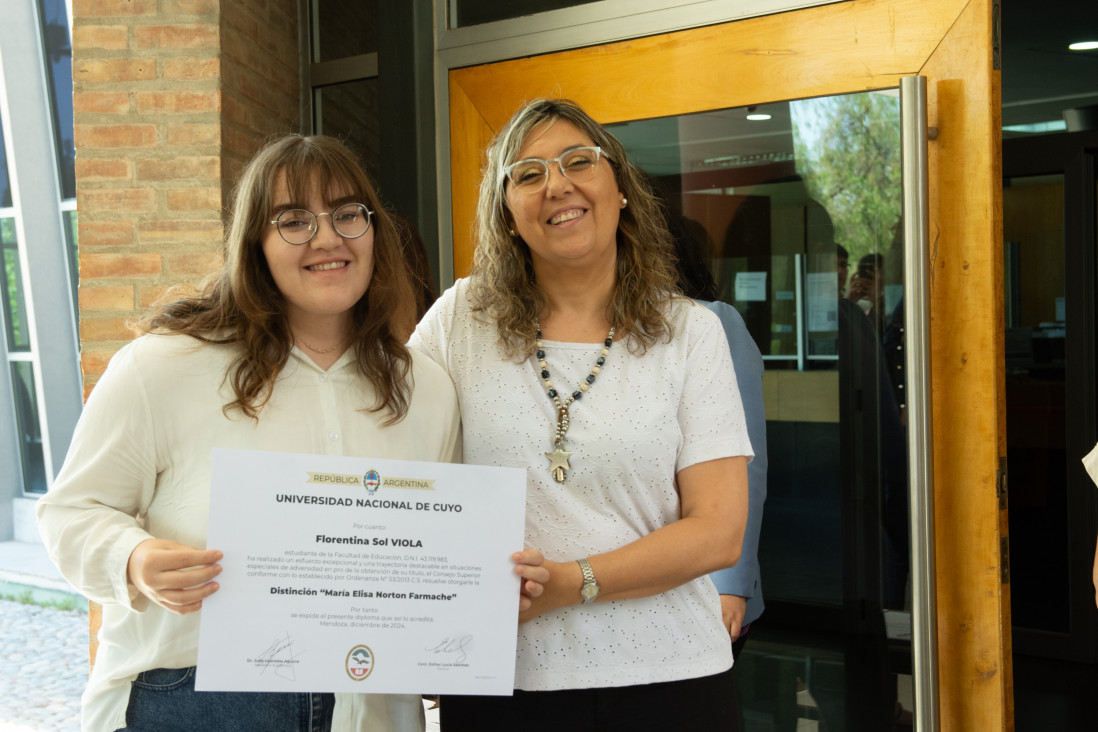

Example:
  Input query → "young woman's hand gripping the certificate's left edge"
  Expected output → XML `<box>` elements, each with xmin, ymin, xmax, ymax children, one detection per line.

<box><xmin>126</xmin><ymin>539</ymin><xmax>223</xmax><ymax>615</ymax></box>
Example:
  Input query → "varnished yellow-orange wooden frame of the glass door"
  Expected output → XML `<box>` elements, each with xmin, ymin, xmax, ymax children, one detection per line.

<box><xmin>444</xmin><ymin>0</ymin><xmax>1013</xmax><ymax>730</ymax></box>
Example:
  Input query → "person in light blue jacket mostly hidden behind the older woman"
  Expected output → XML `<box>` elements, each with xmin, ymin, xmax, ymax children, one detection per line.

<box><xmin>668</xmin><ymin>206</ymin><xmax>766</xmax><ymax>658</ymax></box>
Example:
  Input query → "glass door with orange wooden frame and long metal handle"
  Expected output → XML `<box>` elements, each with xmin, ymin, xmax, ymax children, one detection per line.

<box><xmin>439</xmin><ymin>0</ymin><xmax>1011</xmax><ymax>730</ymax></box>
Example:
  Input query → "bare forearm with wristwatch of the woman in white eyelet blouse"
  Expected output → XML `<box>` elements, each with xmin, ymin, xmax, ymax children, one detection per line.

<box><xmin>519</xmin><ymin>457</ymin><xmax>748</xmax><ymax>622</ymax></box>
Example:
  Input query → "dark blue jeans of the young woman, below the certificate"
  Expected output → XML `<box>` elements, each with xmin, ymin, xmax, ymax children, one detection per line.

<box><xmin>122</xmin><ymin>666</ymin><xmax>335</xmax><ymax>732</ymax></box>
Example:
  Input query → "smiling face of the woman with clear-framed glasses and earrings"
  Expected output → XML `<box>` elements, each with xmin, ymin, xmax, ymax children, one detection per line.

<box><xmin>506</xmin><ymin>120</ymin><xmax>621</xmax><ymax>270</ymax></box>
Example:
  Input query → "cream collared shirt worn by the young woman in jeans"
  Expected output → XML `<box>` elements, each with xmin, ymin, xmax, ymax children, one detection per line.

<box><xmin>37</xmin><ymin>335</ymin><xmax>460</xmax><ymax>732</ymax></box>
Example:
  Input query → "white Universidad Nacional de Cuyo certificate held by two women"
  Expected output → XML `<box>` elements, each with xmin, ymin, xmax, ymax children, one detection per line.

<box><xmin>195</xmin><ymin>450</ymin><xmax>526</xmax><ymax>695</ymax></box>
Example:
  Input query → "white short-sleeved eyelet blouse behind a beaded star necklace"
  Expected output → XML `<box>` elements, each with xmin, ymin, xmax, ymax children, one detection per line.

<box><xmin>410</xmin><ymin>280</ymin><xmax>752</xmax><ymax>690</ymax></box>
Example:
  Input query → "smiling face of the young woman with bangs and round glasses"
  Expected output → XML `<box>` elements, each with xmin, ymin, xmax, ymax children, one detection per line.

<box><xmin>260</xmin><ymin>173</ymin><xmax>374</xmax><ymax>338</ymax></box>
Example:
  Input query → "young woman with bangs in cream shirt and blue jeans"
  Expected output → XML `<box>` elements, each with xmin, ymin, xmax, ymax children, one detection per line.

<box><xmin>37</xmin><ymin>135</ymin><xmax>459</xmax><ymax>732</ymax></box>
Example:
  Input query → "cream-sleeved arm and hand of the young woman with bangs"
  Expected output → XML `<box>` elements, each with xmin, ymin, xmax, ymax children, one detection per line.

<box><xmin>35</xmin><ymin>337</ymin><xmax>220</xmax><ymax>611</ymax></box>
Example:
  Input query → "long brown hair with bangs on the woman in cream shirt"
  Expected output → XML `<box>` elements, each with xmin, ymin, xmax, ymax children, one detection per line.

<box><xmin>137</xmin><ymin>135</ymin><xmax>415</xmax><ymax>425</ymax></box>
